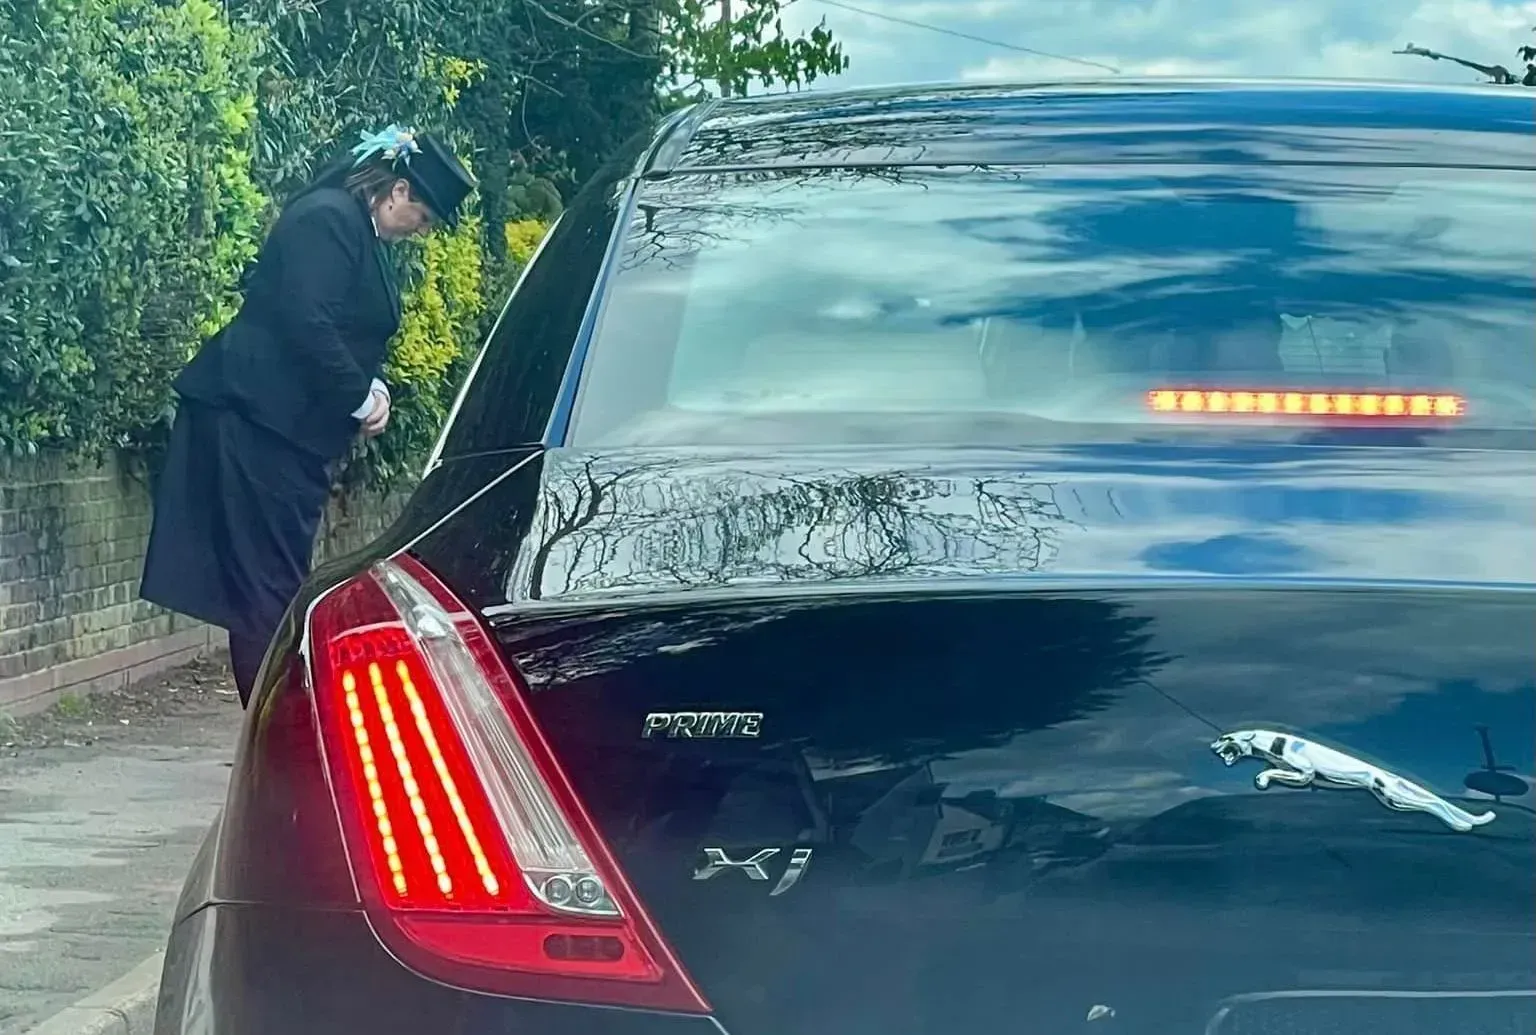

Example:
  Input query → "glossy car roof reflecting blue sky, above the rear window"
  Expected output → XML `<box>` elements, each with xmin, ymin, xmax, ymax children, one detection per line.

<box><xmin>667</xmin><ymin>80</ymin><xmax>1536</xmax><ymax>172</ymax></box>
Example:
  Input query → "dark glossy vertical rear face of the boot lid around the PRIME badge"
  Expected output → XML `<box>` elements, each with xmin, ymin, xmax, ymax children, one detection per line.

<box><xmin>502</xmin><ymin>584</ymin><xmax>1536</xmax><ymax>1035</ymax></box>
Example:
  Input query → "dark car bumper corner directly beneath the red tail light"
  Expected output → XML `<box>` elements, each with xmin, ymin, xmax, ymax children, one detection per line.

<box><xmin>155</xmin><ymin>904</ymin><xmax>722</xmax><ymax>1035</ymax></box>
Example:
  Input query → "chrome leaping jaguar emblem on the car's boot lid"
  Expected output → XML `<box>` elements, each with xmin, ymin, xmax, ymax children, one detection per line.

<box><xmin>1210</xmin><ymin>729</ymin><xmax>1495</xmax><ymax>834</ymax></box>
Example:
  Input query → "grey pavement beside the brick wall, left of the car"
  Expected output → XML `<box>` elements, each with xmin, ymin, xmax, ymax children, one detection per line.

<box><xmin>0</xmin><ymin>662</ymin><xmax>241</xmax><ymax>1035</ymax></box>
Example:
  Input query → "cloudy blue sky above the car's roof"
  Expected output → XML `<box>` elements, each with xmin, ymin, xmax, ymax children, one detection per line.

<box><xmin>785</xmin><ymin>0</ymin><xmax>1536</xmax><ymax>86</ymax></box>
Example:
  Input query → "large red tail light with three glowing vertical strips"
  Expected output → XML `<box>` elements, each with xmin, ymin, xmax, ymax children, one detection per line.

<box><xmin>309</xmin><ymin>557</ymin><xmax>708</xmax><ymax>1012</ymax></box>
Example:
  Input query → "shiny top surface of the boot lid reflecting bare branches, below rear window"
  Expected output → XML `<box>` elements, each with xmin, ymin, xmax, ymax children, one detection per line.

<box><xmin>408</xmin><ymin>444</ymin><xmax>1536</xmax><ymax>613</ymax></box>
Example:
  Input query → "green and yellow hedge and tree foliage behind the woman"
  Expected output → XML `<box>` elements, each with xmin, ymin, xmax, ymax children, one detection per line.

<box><xmin>0</xmin><ymin>0</ymin><xmax>846</xmax><ymax>479</ymax></box>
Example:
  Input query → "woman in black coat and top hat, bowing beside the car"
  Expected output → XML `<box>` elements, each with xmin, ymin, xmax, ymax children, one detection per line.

<box><xmin>140</xmin><ymin>126</ymin><xmax>475</xmax><ymax>705</ymax></box>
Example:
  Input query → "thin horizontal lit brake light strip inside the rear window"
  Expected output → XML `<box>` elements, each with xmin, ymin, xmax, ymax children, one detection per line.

<box><xmin>1147</xmin><ymin>389</ymin><xmax>1467</xmax><ymax>421</ymax></box>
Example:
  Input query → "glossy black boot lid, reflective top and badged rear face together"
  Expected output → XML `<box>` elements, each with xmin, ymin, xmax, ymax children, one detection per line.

<box><xmin>448</xmin><ymin>450</ymin><xmax>1536</xmax><ymax>1032</ymax></box>
